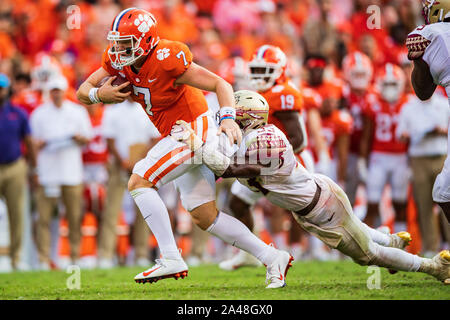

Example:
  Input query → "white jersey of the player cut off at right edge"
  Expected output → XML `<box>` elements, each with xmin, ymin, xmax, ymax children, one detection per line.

<box><xmin>409</xmin><ymin>22</ymin><xmax>450</xmax><ymax>98</ymax></box>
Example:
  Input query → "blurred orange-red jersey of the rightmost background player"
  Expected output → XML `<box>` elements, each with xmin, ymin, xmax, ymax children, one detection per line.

<box><xmin>366</xmin><ymin>95</ymin><xmax>409</xmax><ymax>153</ymax></box>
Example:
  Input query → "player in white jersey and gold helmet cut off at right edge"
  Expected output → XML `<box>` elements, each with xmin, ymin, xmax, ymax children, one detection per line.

<box><xmin>406</xmin><ymin>0</ymin><xmax>450</xmax><ymax>222</ymax></box>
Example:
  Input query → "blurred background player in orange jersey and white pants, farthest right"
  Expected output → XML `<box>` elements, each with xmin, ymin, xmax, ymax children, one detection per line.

<box><xmin>360</xmin><ymin>63</ymin><xmax>409</xmax><ymax>231</ymax></box>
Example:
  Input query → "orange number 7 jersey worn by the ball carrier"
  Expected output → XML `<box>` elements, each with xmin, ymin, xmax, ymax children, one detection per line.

<box><xmin>102</xmin><ymin>40</ymin><xmax>208</xmax><ymax>137</ymax></box>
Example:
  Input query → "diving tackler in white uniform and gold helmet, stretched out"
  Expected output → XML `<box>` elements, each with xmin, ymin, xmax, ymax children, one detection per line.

<box><xmin>173</xmin><ymin>90</ymin><xmax>450</xmax><ymax>284</ymax></box>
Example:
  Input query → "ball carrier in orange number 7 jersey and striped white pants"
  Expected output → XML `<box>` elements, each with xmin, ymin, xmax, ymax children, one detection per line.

<box><xmin>77</xmin><ymin>8</ymin><xmax>291</xmax><ymax>288</ymax></box>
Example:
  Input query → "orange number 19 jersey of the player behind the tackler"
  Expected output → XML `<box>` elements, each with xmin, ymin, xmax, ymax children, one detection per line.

<box><xmin>260</xmin><ymin>80</ymin><xmax>303</xmax><ymax>135</ymax></box>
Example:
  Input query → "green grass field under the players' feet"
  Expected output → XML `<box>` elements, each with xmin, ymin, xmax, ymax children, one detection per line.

<box><xmin>0</xmin><ymin>261</ymin><xmax>450</xmax><ymax>300</ymax></box>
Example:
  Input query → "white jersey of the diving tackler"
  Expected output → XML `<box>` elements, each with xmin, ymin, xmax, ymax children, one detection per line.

<box><xmin>229</xmin><ymin>124</ymin><xmax>316</xmax><ymax>211</ymax></box>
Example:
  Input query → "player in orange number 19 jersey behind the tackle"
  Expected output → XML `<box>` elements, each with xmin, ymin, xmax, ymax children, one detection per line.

<box><xmin>219</xmin><ymin>44</ymin><xmax>314</xmax><ymax>271</ymax></box>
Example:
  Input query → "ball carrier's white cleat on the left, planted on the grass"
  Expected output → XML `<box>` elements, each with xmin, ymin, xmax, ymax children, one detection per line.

<box><xmin>134</xmin><ymin>259</ymin><xmax>188</xmax><ymax>283</ymax></box>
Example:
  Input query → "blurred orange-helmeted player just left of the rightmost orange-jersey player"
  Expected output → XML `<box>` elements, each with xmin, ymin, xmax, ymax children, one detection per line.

<box><xmin>342</xmin><ymin>51</ymin><xmax>374</xmax><ymax>206</ymax></box>
